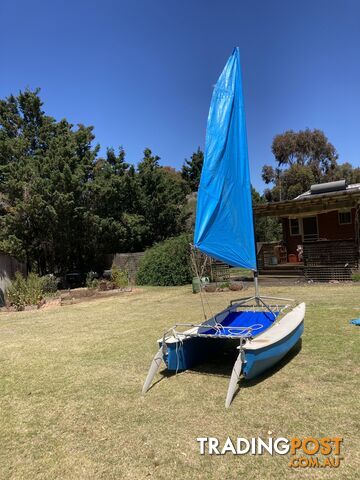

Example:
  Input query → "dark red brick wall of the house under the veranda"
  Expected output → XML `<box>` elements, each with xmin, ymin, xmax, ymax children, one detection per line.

<box><xmin>282</xmin><ymin>208</ymin><xmax>356</xmax><ymax>254</ymax></box>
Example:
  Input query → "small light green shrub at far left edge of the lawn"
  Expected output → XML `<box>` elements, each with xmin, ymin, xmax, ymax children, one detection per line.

<box><xmin>7</xmin><ymin>272</ymin><xmax>44</xmax><ymax>310</ymax></box>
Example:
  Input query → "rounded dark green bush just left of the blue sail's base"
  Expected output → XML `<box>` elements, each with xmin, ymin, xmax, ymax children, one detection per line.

<box><xmin>137</xmin><ymin>234</ymin><xmax>192</xmax><ymax>286</ymax></box>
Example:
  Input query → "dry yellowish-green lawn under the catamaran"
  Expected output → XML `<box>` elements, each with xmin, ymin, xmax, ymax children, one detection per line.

<box><xmin>0</xmin><ymin>284</ymin><xmax>360</xmax><ymax>480</ymax></box>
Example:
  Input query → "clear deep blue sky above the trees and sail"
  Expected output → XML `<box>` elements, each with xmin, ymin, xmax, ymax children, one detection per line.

<box><xmin>0</xmin><ymin>0</ymin><xmax>360</xmax><ymax>191</ymax></box>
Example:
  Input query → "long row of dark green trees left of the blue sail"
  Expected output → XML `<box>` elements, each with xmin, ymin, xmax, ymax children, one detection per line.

<box><xmin>0</xmin><ymin>90</ymin><xmax>194</xmax><ymax>274</ymax></box>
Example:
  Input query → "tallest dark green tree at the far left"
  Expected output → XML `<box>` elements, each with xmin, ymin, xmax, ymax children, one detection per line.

<box><xmin>0</xmin><ymin>90</ymin><xmax>98</xmax><ymax>273</ymax></box>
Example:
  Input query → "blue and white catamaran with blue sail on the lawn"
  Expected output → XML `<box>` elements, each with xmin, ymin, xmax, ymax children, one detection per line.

<box><xmin>142</xmin><ymin>47</ymin><xmax>305</xmax><ymax>408</ymax></box>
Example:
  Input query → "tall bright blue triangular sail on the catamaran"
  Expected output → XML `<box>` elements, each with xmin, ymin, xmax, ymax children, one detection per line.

<box><xmin>194</xmin><ymin>48</ymin><xmax>256</xmax><ymax>271</ymax></box>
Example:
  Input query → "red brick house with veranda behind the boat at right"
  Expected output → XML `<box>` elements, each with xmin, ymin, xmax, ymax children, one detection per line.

<box><xmin>254</xmin><ymin>180</ymin><xmax>360</xmax><ymax>281</ymax></box>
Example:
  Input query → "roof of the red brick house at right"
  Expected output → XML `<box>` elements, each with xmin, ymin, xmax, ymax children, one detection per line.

<box><xmin>254</xmin><ymin>183</ymin><xmax>360</xmax><ymax>217</ymax></box>
